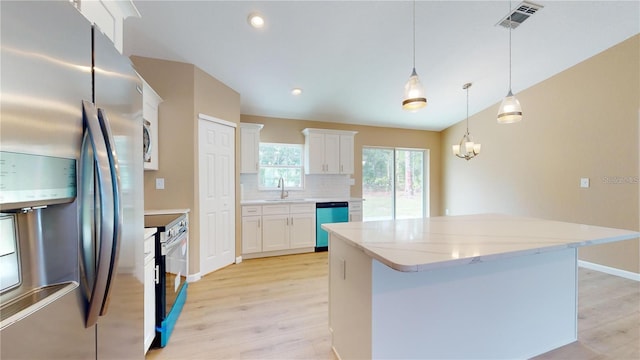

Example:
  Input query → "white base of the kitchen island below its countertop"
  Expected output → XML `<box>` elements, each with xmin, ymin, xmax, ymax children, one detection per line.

<box><xmin>330</xmin><ymin>236</ymin><xmax>577</xmax><ymax>359</ymax></box>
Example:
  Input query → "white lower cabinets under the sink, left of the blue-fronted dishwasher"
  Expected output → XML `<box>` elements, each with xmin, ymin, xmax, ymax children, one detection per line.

<box><xmin>242</xmin><ymin>203</ymin><xmax>316</xmax><ymax>257</ymax></box>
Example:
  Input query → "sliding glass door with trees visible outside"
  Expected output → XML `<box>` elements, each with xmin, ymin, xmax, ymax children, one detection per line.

<box><xmin>362</xmin><ymin>147</ymin><xmax>429</xmax><ymax>221</ymax></box>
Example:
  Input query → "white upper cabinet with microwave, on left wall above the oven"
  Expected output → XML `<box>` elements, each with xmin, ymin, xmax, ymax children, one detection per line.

<box><xmin>141</xmin><ymin>77</ymin><xmax>162</xmax><ymax>170</ymax></box>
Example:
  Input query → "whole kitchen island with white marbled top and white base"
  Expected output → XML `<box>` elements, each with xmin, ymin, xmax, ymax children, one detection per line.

<box><xmin>323</xmin><ymin>214</ymin><xmax>640</xmax><ymax>359</ymax></box>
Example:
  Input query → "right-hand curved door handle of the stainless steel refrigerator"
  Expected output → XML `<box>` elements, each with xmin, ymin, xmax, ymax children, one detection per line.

<box><xmin>98</xmin><ymin>108</ymin><xmax>122</xmax><ymax>315</ymax></box>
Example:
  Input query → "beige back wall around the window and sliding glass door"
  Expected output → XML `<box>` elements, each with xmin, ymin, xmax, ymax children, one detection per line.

<box><xmin>241</xmin><ymin>115</ymin><xmax>441</xmax><ymax>214</ymax></box>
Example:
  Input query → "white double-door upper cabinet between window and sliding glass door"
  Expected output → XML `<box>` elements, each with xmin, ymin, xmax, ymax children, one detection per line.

<box><xmin>302</xmin><ymin>128</ymin><xmax>357</xmax><ymax>174</ymax></box>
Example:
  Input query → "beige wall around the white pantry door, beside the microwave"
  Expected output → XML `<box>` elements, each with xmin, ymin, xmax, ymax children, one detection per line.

<box><xmin>131</xmin><ymin>56</ymin><xmax>240</xmax><ymax>274</ymax></box>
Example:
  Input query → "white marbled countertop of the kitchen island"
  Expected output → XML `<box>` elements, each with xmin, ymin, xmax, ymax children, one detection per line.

<box><xmin>322</xmin><ymin>214</ymin><xmax>640</xmax><ymax>272</ymax></box>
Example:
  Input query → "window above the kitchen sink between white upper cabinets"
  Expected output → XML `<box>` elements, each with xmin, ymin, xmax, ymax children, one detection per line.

<box><xmin>258</xmin><ymin>143</ymin><xmax>304</xmax><ymax>190</ymax></box>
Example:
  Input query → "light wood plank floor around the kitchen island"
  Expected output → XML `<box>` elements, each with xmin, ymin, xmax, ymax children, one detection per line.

<box><xmin>147</xmin><ymin>252</ymin><xmax>640</xmax><ymax>360</ymax></box>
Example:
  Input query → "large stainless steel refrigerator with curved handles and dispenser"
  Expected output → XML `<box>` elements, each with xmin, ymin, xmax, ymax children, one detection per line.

<box><xmin>0</xmin><ymin>0</ymin><xmax>144</xmax><ymax>360</ymax></box>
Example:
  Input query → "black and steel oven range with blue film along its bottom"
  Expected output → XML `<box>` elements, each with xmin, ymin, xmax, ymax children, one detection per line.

<box><xmin>145</xmin><ymin>214</ymin><xmax>189</xmax><ymax>347</ymax></box>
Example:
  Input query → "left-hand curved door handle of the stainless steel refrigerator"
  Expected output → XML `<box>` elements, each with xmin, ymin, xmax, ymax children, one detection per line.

<box><xmin>82</xmin><ymin>101</ymin><xmax>115</xmax><ymax>327</ymax></box>
